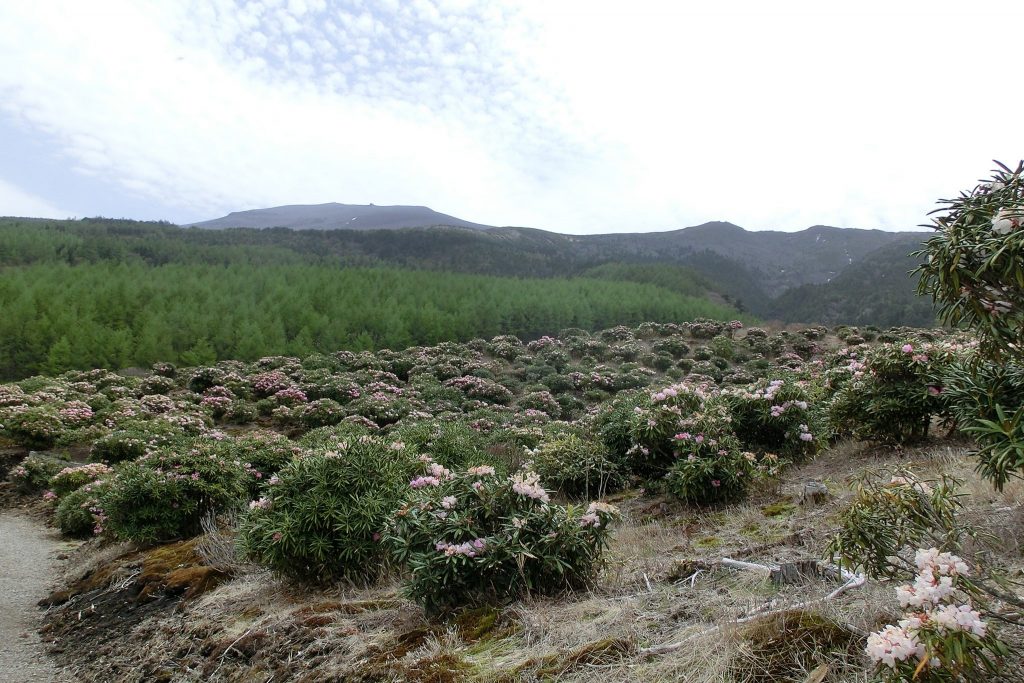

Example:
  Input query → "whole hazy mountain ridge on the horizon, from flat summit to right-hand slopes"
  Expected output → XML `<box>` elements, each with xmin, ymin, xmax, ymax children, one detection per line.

<box><xmin>2</xmin><ymin>204</ymin><xmax>935</xmax><ymax>327</ymax></box>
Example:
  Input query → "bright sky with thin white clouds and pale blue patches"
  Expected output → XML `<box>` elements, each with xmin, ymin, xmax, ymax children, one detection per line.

<box><xmin>0</xmin><ymin>0</ymin><xmax>1024</xmax><ymax>233</ymax></box>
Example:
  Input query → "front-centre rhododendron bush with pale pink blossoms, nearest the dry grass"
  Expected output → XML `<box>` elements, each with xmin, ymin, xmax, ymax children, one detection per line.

<box><xmin>387</xmin><ymin>459</ymin><xmax>617</xmax><ymax>611</ymax></box>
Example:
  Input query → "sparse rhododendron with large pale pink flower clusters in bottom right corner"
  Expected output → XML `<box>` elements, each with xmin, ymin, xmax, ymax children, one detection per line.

<box><xmin>829</xmin><ymin>470</ymin><xmax>1024</xmax><ymax>683</ymax></box>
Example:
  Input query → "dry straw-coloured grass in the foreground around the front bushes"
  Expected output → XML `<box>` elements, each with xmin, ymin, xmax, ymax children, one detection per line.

<box><xmin>39</xmin><ymin>442</ymin><xmax>1024</xmax><ymax>683</ymax></box>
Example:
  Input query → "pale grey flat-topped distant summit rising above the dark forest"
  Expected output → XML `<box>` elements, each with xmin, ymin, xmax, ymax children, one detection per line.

<box><xmin>190</xmin><ymin>203</ymin><xmax>490</xmax><ymax>230</ymax></box>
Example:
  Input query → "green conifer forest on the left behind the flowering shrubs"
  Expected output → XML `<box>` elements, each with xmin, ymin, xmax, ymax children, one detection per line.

<box><xmin>0</xmin><ymin>219</ymin><xmax>737</xmax><ymax>378</ymax></box>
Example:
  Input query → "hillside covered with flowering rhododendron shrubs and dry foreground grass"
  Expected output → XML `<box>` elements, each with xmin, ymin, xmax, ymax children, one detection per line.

<box><xmin>0</xmin><ymin>323</ymin><xmax>1024</xmax><ymax>683</ymax></box>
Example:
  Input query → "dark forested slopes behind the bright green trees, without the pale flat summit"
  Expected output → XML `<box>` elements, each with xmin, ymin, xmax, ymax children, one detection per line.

<box><xmin>0</xmin><ymin>214</ymin><xmax>933</xmax><ymax>325</ymax></box>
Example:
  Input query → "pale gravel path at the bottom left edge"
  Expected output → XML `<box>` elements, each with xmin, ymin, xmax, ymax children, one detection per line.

<box><xmin>0</xmin><ymin>510</ymin><xmax>69</xmax><ymax>683</ymax></box>
